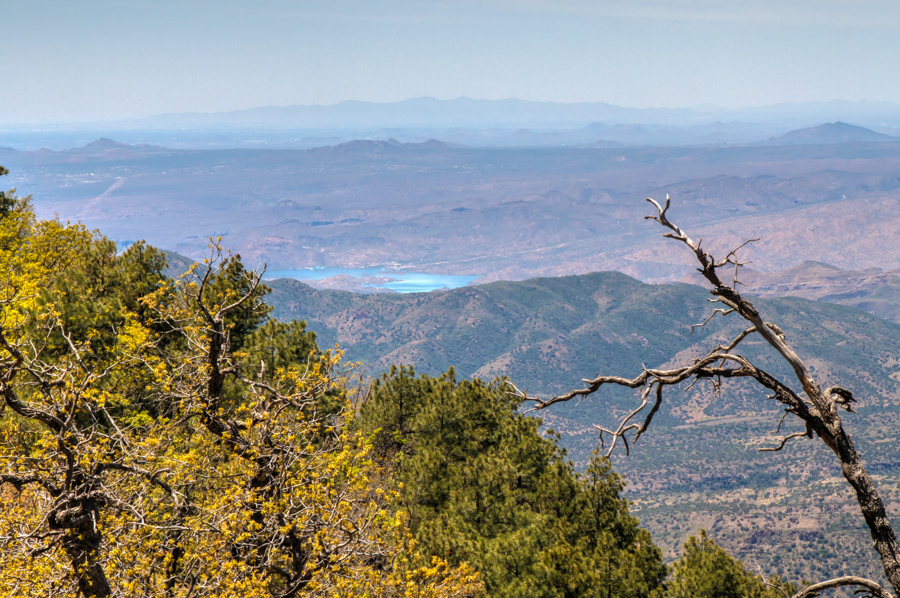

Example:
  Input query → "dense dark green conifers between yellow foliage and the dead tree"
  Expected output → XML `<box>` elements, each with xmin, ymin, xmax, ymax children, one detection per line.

<box><xmin>361</xmin><ymin>367</ymin><xmax>666</xmax><ymax>598</ymax></box>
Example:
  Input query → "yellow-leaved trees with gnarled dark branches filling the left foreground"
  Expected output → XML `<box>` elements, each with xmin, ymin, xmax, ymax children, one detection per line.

<box><xmin>0</xmin><ymin>201</ymin><xmax>479</xmax><ymax>598</ymax></box>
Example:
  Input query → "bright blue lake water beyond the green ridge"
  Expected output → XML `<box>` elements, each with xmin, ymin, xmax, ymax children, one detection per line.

<box><xmin>265</xmin><ymin>267</ymin><xmax>478</xmax><ymax>293</ymax></box>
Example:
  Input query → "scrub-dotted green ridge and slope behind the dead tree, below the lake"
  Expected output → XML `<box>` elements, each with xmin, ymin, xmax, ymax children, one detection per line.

<box><xmin>271</xmin><ymin>272</ymin><xmax>900</xmax><ymax>592</ymax></box>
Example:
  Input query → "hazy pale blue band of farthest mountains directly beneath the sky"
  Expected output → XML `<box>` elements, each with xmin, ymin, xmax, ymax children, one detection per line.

<box><xmin>7</xmin><ymin>97</ymin><xmax>900</xmax><ymax>150</ymax></box>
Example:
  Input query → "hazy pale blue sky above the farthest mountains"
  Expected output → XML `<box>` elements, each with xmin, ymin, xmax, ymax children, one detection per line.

<box><xmin>0</xmin><ymin>0</ymin><xmax>900</xmax><ymax>125</ymax></box>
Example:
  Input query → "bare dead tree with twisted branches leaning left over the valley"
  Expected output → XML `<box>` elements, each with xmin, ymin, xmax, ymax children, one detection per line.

<box><xmin>515</xmin><ymin>196</ymin><xmax>900</xmax><ymax>598</ymax></box>
